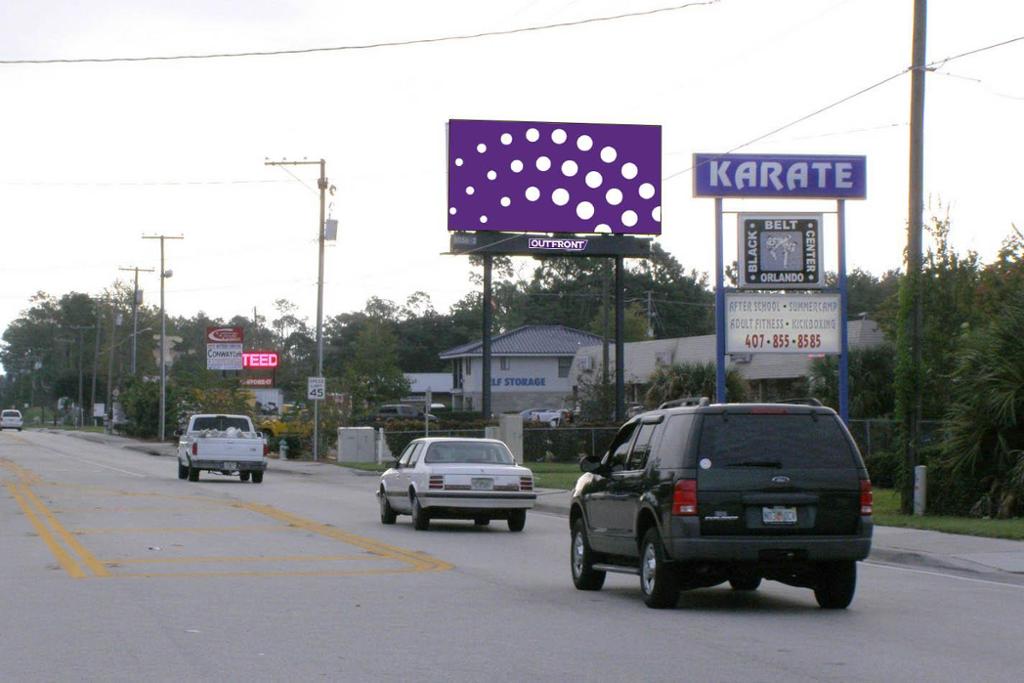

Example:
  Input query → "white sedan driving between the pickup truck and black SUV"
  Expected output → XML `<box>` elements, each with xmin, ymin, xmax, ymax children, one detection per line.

<box><xmin>377</xmin><ymin>438</ymin><xmax>537</xmax><ymax>531</ymax></box>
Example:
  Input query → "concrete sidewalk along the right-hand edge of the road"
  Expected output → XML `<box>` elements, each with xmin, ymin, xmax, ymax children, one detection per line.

<box><xmin>47</xmin><ymin>430</ymin><xmax>1024</xmax><ymax>585</ymax></box>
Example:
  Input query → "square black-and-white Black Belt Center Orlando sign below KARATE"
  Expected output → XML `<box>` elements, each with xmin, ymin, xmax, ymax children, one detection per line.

<box><xmin>736</xmin><ymin>213</ymin><xmax>824</xmax><ymax>289</ymax></box>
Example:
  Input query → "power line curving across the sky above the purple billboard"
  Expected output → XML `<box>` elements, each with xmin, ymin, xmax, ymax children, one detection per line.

<box><xmin>0</xmin><ymin>0</ymin><xmax>720</xmax><ymax>66</ymax></box>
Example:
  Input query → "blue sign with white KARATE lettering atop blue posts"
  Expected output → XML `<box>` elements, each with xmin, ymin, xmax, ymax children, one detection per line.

<box><xmin>693</xmin><ymin>154</ymin><xmax>867</xmax><ymax>200</ymax></box>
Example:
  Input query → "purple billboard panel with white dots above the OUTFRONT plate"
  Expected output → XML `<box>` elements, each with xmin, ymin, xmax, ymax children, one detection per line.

<box><xmin>449</xmin><ymin>119</ymin><xmax>662</xmax><ymax>239</ymax></box>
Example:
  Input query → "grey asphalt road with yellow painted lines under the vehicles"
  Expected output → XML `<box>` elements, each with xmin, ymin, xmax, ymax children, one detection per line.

<box><xmin>0</xmin><ymin>432</ymin><xmax>1024</xmax><ymax>682</ymax></box>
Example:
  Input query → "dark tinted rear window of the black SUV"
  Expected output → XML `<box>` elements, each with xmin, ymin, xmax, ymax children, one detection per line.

<box><xmin>699</xmin><ymin>414</ymin><xmax>858</xmax><ymax>468</ymax></box>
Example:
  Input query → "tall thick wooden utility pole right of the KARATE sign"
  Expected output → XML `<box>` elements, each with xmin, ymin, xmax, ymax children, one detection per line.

<box><xmin>901</xmin><ymin>0</ymin><xmax>928</xmax><ymax>512</ymax></box>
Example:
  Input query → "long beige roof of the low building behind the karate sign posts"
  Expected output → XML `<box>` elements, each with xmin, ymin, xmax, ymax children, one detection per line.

<box><xmin>572</xmin><ymin>319</ymin><xmax>885</xmax><ymax>384</ymax></box>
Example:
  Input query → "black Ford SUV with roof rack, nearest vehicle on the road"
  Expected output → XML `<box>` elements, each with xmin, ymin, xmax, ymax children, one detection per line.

<box><xmin>569</xmin><ymin>401</ymin><xmax>873</xmax><ymax>609</ymax></box>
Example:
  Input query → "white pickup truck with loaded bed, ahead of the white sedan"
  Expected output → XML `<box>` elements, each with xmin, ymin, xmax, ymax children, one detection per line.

<box><xmin>178</xmin><ymin>415</ymin><xmax>266</xmax><ymax>483</ymax></box>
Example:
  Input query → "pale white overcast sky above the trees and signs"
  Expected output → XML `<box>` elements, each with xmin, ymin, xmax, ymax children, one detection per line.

<box><xmin>0</xmin><ymin>0</ymin><xmax>1024</xmax><ymax>370</ymax></box>
